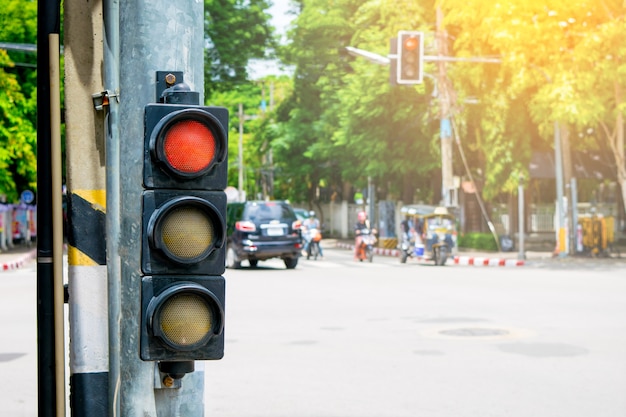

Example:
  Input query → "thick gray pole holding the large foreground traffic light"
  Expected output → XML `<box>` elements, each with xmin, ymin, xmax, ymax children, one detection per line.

<box><xmin>116</xmin><ymin>0</ymin><xmax>204</xmax><ymax>417</ymax></box>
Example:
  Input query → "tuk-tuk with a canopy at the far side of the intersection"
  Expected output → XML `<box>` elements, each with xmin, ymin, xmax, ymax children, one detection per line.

<box><xmin>400</xmin><ymin>204</ymin><xmax>457</xmax><ymax>265</ymax></box>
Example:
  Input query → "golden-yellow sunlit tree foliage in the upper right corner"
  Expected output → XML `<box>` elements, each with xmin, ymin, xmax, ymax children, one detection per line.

<box><xmin>442</xmin><ymin>0</ymin><xmax>626</xmax><ymax>207</ymax></box>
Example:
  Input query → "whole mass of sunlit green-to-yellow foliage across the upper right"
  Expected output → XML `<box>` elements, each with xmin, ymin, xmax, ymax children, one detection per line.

<box><xmin>202</xmin><ymin>0</ymin><xmax>626</xmax><ymax>211</ymax></box>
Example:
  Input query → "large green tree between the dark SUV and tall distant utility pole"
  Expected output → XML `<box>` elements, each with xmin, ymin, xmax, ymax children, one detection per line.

<box><xmin>273</xmin><ymin>0</ymin><xmax>437</xmax><ymax>206</ymax></box>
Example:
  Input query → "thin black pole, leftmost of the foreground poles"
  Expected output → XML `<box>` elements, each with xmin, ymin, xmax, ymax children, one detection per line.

<box><xmin>37</xmin><ymin>0</ymin><xmax>65</xmax><ymax>417</ymax></box>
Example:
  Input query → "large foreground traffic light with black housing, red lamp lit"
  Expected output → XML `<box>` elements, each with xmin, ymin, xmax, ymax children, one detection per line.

<box><xmin>140</xmin><ymin>78</ymin><xmax>228</xmax><ymax>377</ymax></box>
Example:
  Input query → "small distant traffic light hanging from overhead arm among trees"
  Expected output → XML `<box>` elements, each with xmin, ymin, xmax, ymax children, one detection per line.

<box><xmin>396</xmin><ymin>30</ymin><xmax>424</xmax><ymax>84</ymax></box>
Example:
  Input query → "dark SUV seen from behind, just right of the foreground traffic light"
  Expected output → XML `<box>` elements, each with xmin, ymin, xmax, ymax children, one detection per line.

<box><xmin>226</xmin><ymin>201</ymin><xmax>302</xmax><ymax>269</ymax></box>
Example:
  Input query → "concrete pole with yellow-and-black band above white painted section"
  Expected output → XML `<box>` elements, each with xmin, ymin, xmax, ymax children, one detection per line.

<box><xmin>63</xmin><ymin>0</ymin><xmax>109</xmax><ymax>417</ymax></box>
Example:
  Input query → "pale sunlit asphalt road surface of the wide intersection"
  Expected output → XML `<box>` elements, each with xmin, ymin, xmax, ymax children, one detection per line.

<box><xmin>0</xmin><ymin>248</ymin><xmax>626</xmax><ymax>417</ymax></box>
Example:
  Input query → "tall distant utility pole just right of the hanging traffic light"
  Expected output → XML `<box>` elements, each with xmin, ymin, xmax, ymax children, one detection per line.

<box><xmin>436</xmin><ymin>6</ymin><xmax>455</xmax><ymax>207</ymax></box>
